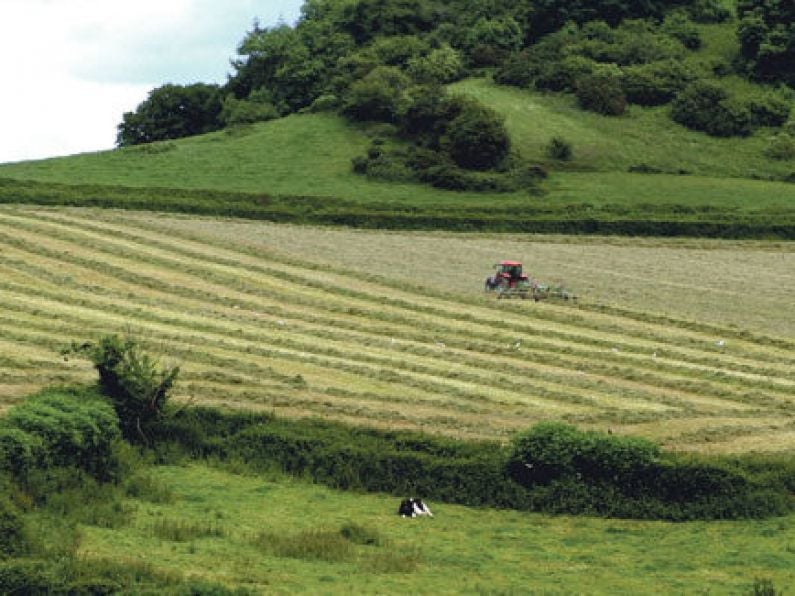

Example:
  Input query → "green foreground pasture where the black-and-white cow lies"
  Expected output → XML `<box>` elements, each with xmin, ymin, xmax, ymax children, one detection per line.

<box><xmin>80</xmin><ymin>466</ymin><xmax>795</xmax><ymax>594</ymax></box>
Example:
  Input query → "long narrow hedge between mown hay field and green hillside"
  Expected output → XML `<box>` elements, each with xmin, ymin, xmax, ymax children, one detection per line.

<box><xmin>0</xmin><ymin>178</ymin><xmax>795</xmax><ymax>240</ymax></box>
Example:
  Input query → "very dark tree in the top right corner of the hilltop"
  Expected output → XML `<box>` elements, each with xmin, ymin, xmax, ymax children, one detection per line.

<box><xmin>737</xmin><ymin>0</ymin><xmax>795</xmax><ymax>86</ymax></box>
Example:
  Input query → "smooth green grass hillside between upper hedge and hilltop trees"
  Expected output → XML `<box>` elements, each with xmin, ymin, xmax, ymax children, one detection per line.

<box><xmin>0</xmin><ymin>79</ymin><xmax>795</xmax><ymax>224</ymax></box>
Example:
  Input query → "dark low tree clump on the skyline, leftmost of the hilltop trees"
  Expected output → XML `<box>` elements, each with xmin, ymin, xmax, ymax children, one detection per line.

<box><xmin>116</xmin><ymin>83</ymin><xmax>221</xmax><ymax>147</ymax></box>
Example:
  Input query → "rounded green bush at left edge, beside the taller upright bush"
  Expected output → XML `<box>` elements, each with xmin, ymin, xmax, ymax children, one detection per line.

<box><xmin>0</xmin><ymin>388</ymin><xmax>120</xmax><ymax>479</ymax></box>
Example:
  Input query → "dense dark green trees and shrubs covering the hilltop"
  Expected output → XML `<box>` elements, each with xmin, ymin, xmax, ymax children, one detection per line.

<box><xmin>117</xmin><ymin>0</ymin><xmax>795</xmax><ymax>179</ymax></box>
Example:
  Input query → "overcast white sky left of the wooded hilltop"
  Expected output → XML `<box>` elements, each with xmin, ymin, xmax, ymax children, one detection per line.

<box><xmin>0</xmin><ymin>0</ymin><xmax>303</xmax><ymax>163</ymax></box>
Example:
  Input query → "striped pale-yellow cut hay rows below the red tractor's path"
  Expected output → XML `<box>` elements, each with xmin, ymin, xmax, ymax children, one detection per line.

<box><xmin>0</xmin><ymin>208</ymin><xmax>795</xmax><ymax>451</ymax></box>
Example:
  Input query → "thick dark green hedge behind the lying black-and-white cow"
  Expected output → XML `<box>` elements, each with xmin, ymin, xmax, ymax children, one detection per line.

<box><xmin>151</xmin><ymin>408</ymin><xmax>795</xmax><ymax>520</ymax></box>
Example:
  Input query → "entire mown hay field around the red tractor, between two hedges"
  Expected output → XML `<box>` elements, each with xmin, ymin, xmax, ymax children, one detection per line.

<box><xmin>0</xmin><ymin>207</ymin><xmax>795</xmax><ymax>452</ymax></box>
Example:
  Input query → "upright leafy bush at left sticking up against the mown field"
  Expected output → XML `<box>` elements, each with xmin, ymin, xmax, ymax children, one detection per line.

<box><xmin>65</xmin><ymin>335</ymin><xmax>179</xmax><ymax>442</ymax></box>
